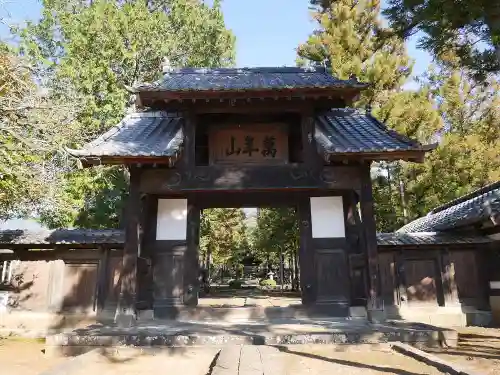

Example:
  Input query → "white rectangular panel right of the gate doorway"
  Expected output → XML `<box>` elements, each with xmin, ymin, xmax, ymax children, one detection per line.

<box><xmin>311</xmin><ymin>197</ymin><xmax>345</xmax><ymax>238</ymax></box>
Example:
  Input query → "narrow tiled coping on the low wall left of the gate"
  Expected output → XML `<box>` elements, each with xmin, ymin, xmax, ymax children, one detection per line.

<box><xmin>0</xmin><ymin>229</ymin><xmax>125</xmax><ymax>248</ymax></box>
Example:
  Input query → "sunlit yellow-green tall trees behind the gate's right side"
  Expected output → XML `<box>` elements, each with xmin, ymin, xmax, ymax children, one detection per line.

<box><xmin>298</xmin><ymin>0</ymin><xmax>500</xmax><ymax>231</ymax></box>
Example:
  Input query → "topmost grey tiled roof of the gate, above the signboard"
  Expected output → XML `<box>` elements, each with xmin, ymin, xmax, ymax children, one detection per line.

<box><xmin>135</xmin><ymin>67</ymin><xmax>368</xmax><ymax>92</ymax></box>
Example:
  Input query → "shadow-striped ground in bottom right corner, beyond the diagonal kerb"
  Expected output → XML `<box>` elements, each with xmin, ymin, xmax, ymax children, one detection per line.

<box><xmin>427</xmin><ymin>327</ymin><xmax>500</xmax><ymax>375</ymax></box>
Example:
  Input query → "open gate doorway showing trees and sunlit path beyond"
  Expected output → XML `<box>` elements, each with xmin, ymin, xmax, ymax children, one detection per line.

<box><xmin>198</xmin><ymin>206</ymin><xmax>301</xmax><ymax>308</ymax></box>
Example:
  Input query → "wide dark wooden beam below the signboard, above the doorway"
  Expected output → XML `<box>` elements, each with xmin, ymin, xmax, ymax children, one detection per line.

<box><xmin>140</xmin><ymin>166</ymin><xmax>360</xmax><ymax>194</ymax></box>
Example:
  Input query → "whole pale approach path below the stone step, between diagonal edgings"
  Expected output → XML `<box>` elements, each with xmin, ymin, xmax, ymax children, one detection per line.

<box><xmin>41</xmin><ymin>345</ymin><xmax>442</xmax><ymax>375</ymax></box>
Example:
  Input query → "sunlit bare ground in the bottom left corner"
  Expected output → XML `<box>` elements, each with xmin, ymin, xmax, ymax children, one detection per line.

<box><xmin>0</xmin><ymin>338</ymin><xmax>66</xmax><ymax>375</ymax></box>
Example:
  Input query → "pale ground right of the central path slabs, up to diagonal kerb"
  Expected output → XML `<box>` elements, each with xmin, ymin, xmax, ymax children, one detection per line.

<box><xmin>282</xmin><ymin>345</ymin><xmax>443</xmax><ymax>375</ymax></box>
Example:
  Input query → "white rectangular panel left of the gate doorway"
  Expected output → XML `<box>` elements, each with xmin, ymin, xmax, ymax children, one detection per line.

<box><xmin>156</xmin><ymin>199</ymin><xmax>187</xmax><ymax>240</ymax></box>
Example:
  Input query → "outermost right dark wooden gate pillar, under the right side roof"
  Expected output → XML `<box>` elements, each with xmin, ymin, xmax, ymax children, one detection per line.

<box><xmin>359</xmin><ymin>162</ymin><xmax>381</xmax><ymax>310</ymax></box>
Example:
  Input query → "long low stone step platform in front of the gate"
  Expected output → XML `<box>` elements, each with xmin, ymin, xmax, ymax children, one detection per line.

<box><xmin>46</xmin><ymin>320</ymin><xmax>458</xmax><ymax>353</ymax></box>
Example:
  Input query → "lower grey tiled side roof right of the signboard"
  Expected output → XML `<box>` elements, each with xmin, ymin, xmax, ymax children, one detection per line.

<box><xmin>316</xmin><ymin>109</ymin><xmax>431</xmax><ymax>161</ymax></box>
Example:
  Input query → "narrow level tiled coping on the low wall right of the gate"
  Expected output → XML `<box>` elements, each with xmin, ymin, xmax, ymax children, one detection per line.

<box><xmin>377</xmin><ymin>232</ymin><xmax>492</xmax><ymax>246</ymax></box>
